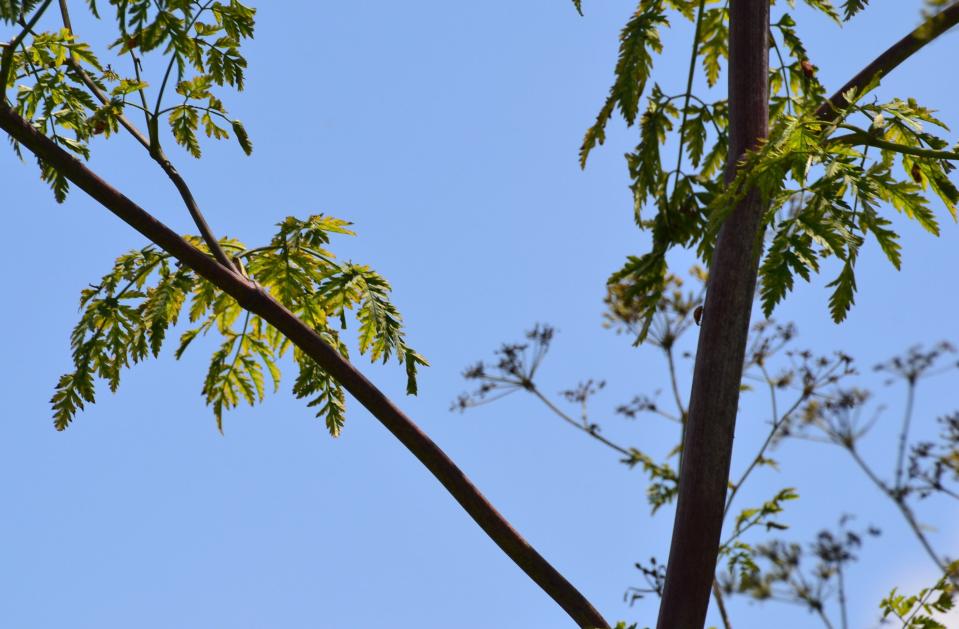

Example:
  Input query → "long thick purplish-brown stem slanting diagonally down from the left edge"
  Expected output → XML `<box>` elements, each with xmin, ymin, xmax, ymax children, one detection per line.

<box><xmin>0</xmin><ymin>103</ymin><xmax>609</xmax><ymax>629</ymax></box>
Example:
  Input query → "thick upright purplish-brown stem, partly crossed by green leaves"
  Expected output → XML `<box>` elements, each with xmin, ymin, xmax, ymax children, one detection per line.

<box><xmin>657</xmin><ymin>0</ymin><xmax>769</xmax><ymax>629</ymax></box>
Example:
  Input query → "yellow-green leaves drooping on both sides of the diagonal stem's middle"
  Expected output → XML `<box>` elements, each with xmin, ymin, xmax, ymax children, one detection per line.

<box><xmin>51</xmin><ymin>215</ymin><xmax>427</xmax><ymax>436</ymax></box>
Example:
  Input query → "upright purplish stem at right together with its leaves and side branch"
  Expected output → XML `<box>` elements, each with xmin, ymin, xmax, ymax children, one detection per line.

<box><xmin>574</xmin><ymin>0</ymin><xmax>959</xmax><ymax>629</ymax></box>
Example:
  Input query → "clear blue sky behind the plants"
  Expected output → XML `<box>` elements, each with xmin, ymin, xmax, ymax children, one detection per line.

<box><xmin>0</xmin><ymin>0</ymin><xmax>959</xmax><ymax>629</ymax></box>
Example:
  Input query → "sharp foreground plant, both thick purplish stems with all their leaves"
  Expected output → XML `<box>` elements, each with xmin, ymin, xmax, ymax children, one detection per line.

<box><xmin>0</xmin><ymin>0</ymin><xmax>959</xmax><ymax>629</ymax></box>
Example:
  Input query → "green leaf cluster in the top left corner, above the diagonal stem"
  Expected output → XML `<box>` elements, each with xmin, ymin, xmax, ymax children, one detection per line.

<box><xmin>0</xmin><ymin>0</ymin><xmax>255</xmax><ymax>202</ymax></box>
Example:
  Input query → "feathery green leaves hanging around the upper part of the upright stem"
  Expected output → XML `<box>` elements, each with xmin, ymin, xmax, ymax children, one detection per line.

<box><xmin>580</xmin><ymin>0</ymin><xmax>959</xmax><ymax>341</ymax></box>
